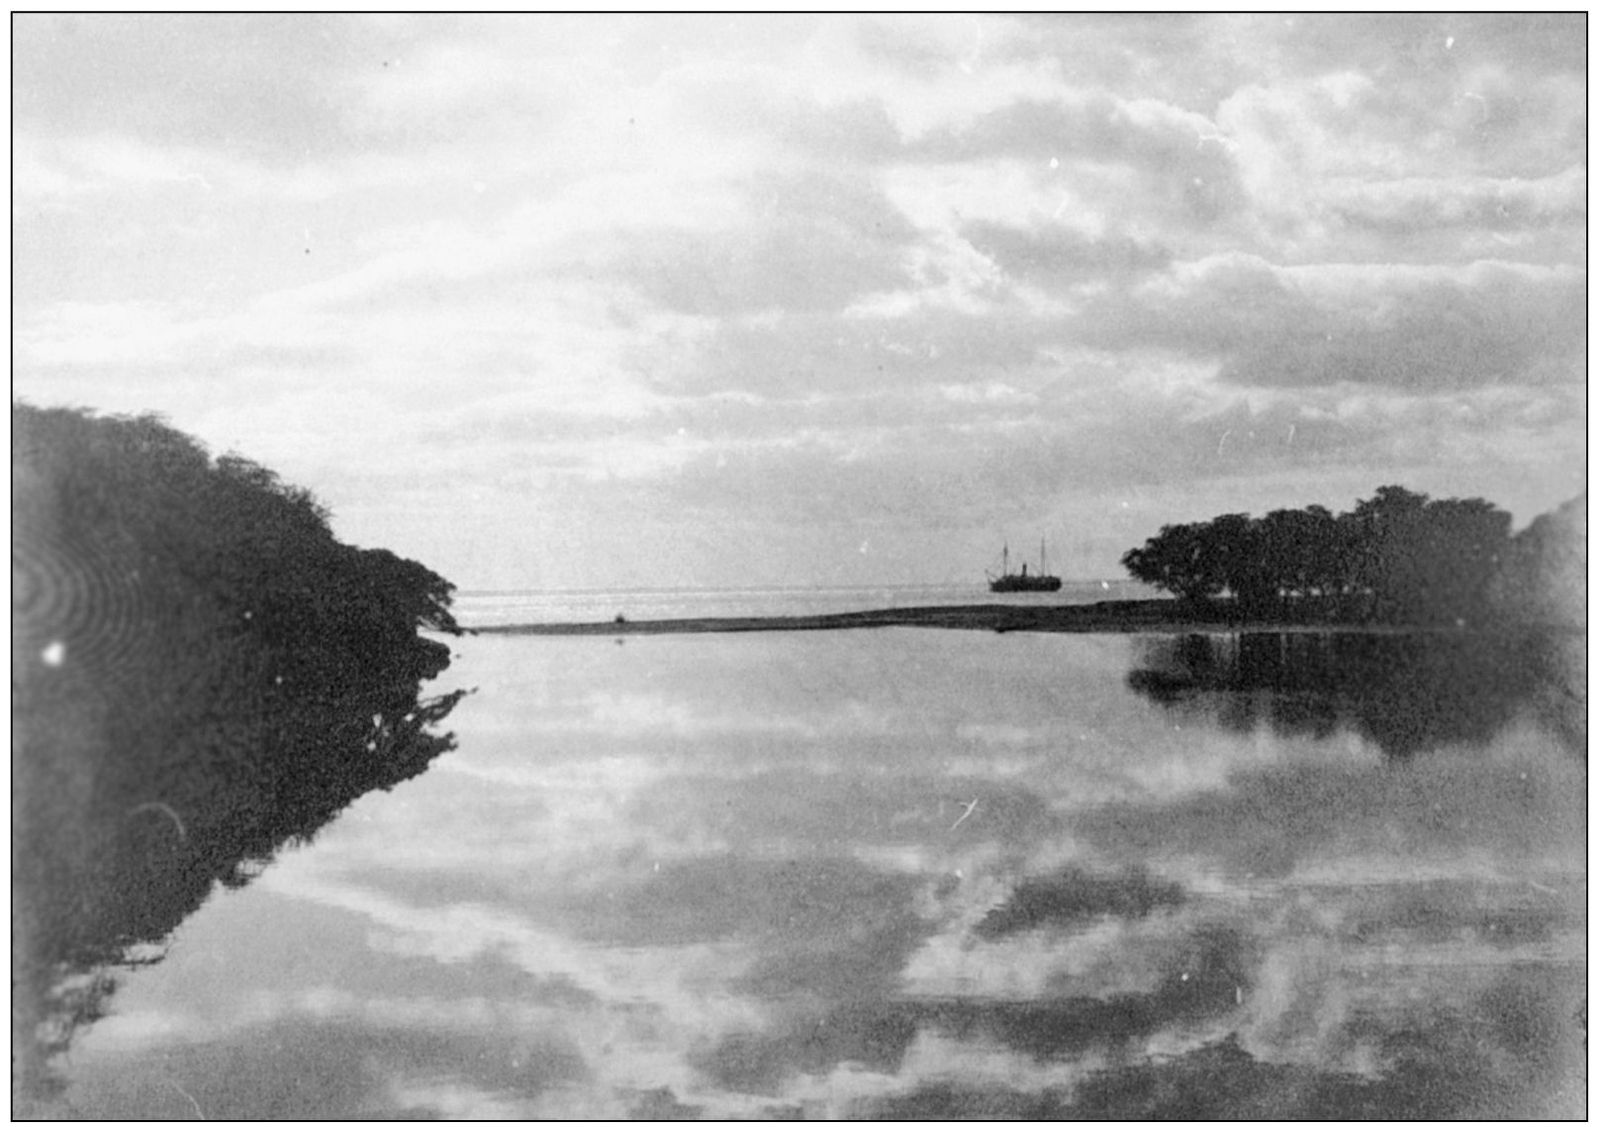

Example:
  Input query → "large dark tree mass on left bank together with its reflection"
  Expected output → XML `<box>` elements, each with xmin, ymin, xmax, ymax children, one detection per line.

<box><xmin>11</xmin><ymin>406</ymin><xmax>462</xmax><ymax>1100</ymax></box>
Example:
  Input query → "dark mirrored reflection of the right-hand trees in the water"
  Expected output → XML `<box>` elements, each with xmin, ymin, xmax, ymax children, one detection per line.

<box><xmin>1129</xmin><ymin>631</ymin><xmax>1586</xmax><ymax>755</ymax></box>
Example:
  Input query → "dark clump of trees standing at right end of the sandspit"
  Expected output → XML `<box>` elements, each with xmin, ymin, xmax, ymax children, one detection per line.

<box><xmin>1122</xmin><ymin>485</ymin><xmax>1512</xmax><ymax>623</ymax></box>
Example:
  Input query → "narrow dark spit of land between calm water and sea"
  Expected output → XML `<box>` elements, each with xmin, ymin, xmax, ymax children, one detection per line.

<box><xmin>470</xmin><ymin>599</ymin><xmax>1474</xmax><ymax>636</ymax></box>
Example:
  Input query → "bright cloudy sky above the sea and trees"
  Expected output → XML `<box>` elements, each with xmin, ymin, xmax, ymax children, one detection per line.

<box><xmin>11</xmin><ymin>13</ymin><xmax>1587</xmax><ymax>591</ymax></box>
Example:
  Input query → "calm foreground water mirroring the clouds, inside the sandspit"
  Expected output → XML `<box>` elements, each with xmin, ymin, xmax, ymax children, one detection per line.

<box><xmin>34</xmin><ymin>631</ymin><xmax>1586</xmax><ymax>1119</ymax></box>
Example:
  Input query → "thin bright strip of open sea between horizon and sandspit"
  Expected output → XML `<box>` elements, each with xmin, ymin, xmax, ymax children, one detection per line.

<box><xmin>452</xmin><ymin>580</ymin><xmax>1161</xmax><ymax>630</ymax></box>
